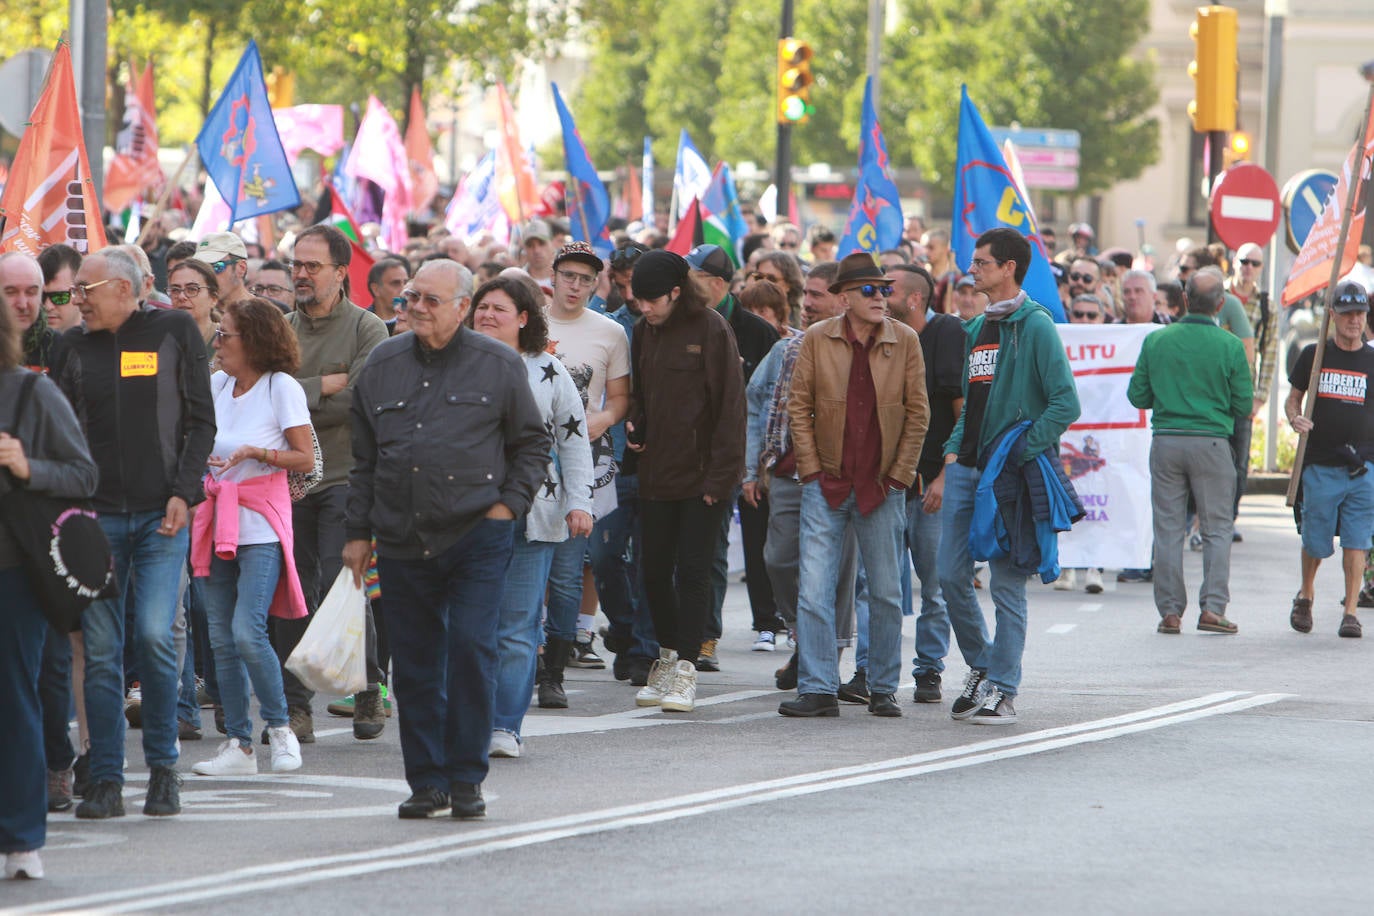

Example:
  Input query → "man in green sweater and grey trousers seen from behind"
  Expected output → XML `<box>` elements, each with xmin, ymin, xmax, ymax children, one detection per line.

<box><xmin>1127</xmin><ymin>266</ymin><xmax>1254</xmax><ymax>634</ymax></box>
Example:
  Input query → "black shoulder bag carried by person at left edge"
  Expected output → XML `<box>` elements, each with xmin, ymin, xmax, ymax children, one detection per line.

<box><xmin>0</xmin><ymin>374</ymin><xmax>117</xmax><ymax>633</ymax></box>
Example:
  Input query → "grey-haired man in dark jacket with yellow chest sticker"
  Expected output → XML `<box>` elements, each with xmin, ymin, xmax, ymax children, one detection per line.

<box><xmin>62</xmin><ymin>249</ymin><xmax>214</xmax><ymax>818</ymax></box>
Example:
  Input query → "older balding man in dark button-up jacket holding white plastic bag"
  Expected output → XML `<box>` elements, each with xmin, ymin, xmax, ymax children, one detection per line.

<box><xmin>344</xmin><ymin>261</ymin><xmax>551</xmax><ymax>818</ymax></box>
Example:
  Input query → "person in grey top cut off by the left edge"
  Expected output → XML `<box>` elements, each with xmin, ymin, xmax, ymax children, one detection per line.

<box><xmin>0</xmin><ymin>300</ymin><xmax>99</xmax><ymax>879</ymax></box>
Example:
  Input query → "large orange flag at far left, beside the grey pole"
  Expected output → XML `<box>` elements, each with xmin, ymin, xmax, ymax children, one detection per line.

<box><xmin>0</xmin><ymin>40</ymin><xmax>106</xmax><ymax>255</ymax></box>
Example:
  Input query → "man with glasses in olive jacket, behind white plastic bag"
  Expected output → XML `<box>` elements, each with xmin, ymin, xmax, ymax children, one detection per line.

<box><xmin>278</xmin><ymin>225</ymin><xmax>387</xmax><ymax>744</ymax></box>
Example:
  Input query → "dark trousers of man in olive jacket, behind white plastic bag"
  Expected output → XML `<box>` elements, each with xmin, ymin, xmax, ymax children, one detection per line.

<box><xmin>271</xmin><ymin>483</ymin><xmax>348</xmax><ymax>709</ymax></box>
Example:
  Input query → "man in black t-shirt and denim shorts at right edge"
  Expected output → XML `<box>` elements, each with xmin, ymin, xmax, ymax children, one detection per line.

<box><xmin>1285</xmin><ymin>283</ymin><xmax>1374</xmax><ymax>639</ymax></box>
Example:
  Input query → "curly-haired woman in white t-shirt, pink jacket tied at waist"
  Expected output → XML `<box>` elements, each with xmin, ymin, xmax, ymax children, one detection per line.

<box><xmin>191</xmin><ymin>299</ymin><xmax>315</xmax><ymax>776</ymax></box>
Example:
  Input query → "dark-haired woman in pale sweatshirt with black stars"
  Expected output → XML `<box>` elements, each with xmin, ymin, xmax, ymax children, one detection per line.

<box><xmin>464</xmin><ymin>277</ymin><xmax>592</xmax><ymax>757</ymax></box>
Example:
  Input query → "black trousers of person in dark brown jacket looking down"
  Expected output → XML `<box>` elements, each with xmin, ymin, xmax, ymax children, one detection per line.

<box><xmin>639</xmin><ymin>497</ymin><xmax>730</xmax><ymax>662</ymax></box>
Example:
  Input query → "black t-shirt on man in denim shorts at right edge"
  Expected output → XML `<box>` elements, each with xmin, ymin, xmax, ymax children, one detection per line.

<box><xmin>1289</xmin><ymin>341</ymin><xmax>1374</xmax><ymax>467</ymax></box>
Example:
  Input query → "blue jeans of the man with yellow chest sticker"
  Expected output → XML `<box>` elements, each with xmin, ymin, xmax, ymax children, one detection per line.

<box><xmin>81</xmin><ymin>511</ymin><xmax>190</xmax><ymax>786</ymax></box>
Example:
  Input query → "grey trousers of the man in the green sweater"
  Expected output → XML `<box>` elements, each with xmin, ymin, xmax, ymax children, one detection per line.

<box><xmin>1150</xmin><ymin>434</ymin><xmax>1235</xmax><ymax>617</ymax></box>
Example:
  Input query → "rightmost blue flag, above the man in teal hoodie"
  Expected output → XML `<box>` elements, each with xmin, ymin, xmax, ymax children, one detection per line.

<box><xmin>949</xmin><ymin>87</ymin><xmax>1065</xmax><ymax>321</ymax></box>
